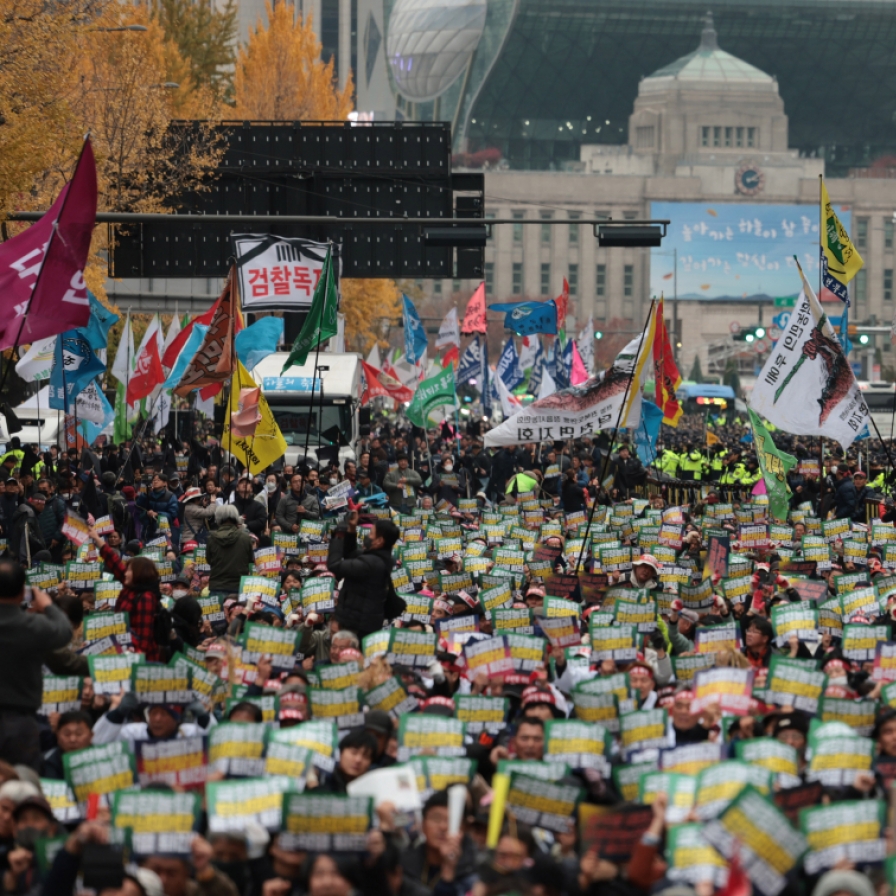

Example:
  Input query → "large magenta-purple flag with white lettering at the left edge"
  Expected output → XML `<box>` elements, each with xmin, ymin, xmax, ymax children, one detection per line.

<box><xmin>0</xmin><ymin>139</ymin><xmax>97</xmax><ymax>350</ymax></box>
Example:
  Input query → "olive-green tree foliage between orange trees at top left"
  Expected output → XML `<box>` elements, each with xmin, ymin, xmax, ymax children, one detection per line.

<box><xmin>151</xmin><ymin>0</ymin><xmax>237</xmax><ymax>98</ymax></box>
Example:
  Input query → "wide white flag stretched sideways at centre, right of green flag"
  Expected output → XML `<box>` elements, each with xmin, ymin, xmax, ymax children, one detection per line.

<box><xmin>485</xmin><ymin>336</ymin><xmax>650</xmax><ymax>448</ymax></box>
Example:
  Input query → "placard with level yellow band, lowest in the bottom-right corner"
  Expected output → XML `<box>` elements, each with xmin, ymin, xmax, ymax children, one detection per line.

<box><xmin>800</xmin><ymin>800</ymin><xmax>887</xmax><ymax>875</ymax></box>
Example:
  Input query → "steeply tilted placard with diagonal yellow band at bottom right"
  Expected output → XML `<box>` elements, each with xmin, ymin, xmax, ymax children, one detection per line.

<box><xmin>703</xmin><ymin>786</ymin><xmax>806</xmax><ymax>896</ymax></box>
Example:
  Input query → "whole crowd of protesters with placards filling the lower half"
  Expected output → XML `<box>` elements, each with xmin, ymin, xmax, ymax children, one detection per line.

<box><xmin>0</xmin><ymin>418</ymin><xmax>896</xmax><ymax>896</ymax></box>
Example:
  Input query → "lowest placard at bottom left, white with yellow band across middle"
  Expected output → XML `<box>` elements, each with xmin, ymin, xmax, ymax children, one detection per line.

<box><xmin>112</xmin><ymin>791</ymin><xmax>200</xmax><ymax>856</ymax></box>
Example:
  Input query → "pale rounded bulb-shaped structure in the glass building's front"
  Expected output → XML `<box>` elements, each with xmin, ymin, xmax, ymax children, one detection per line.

<box><xmin>386</xmin><ymin>0</ymin><xmax>487</xmax><ymax>102</ymax></box>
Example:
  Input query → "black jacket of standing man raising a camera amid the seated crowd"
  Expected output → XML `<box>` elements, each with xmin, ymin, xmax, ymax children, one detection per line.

<box><xmin>327</xmin><ymin>527</ymin><xmax>394</xmax><ymax>638</ymax></box>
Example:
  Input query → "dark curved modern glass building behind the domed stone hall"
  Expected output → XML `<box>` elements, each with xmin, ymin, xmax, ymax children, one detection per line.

<box><xmin>383</xmin><ymin>0</ymin><xmax>896</xmax><ymax>176</ymax></box>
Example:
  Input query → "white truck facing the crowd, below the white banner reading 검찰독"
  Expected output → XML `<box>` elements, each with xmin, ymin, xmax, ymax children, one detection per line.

<box><xmin>252</xmin><ymin>352</ymin><xmax>361</xmax><ymax>467</ymax></box>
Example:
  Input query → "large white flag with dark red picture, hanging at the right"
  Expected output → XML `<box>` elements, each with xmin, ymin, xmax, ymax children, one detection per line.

<box><xmin>750</xmin><ymin>262</ymin><xmax>870</xmax><ymax>451</ymax></box>
